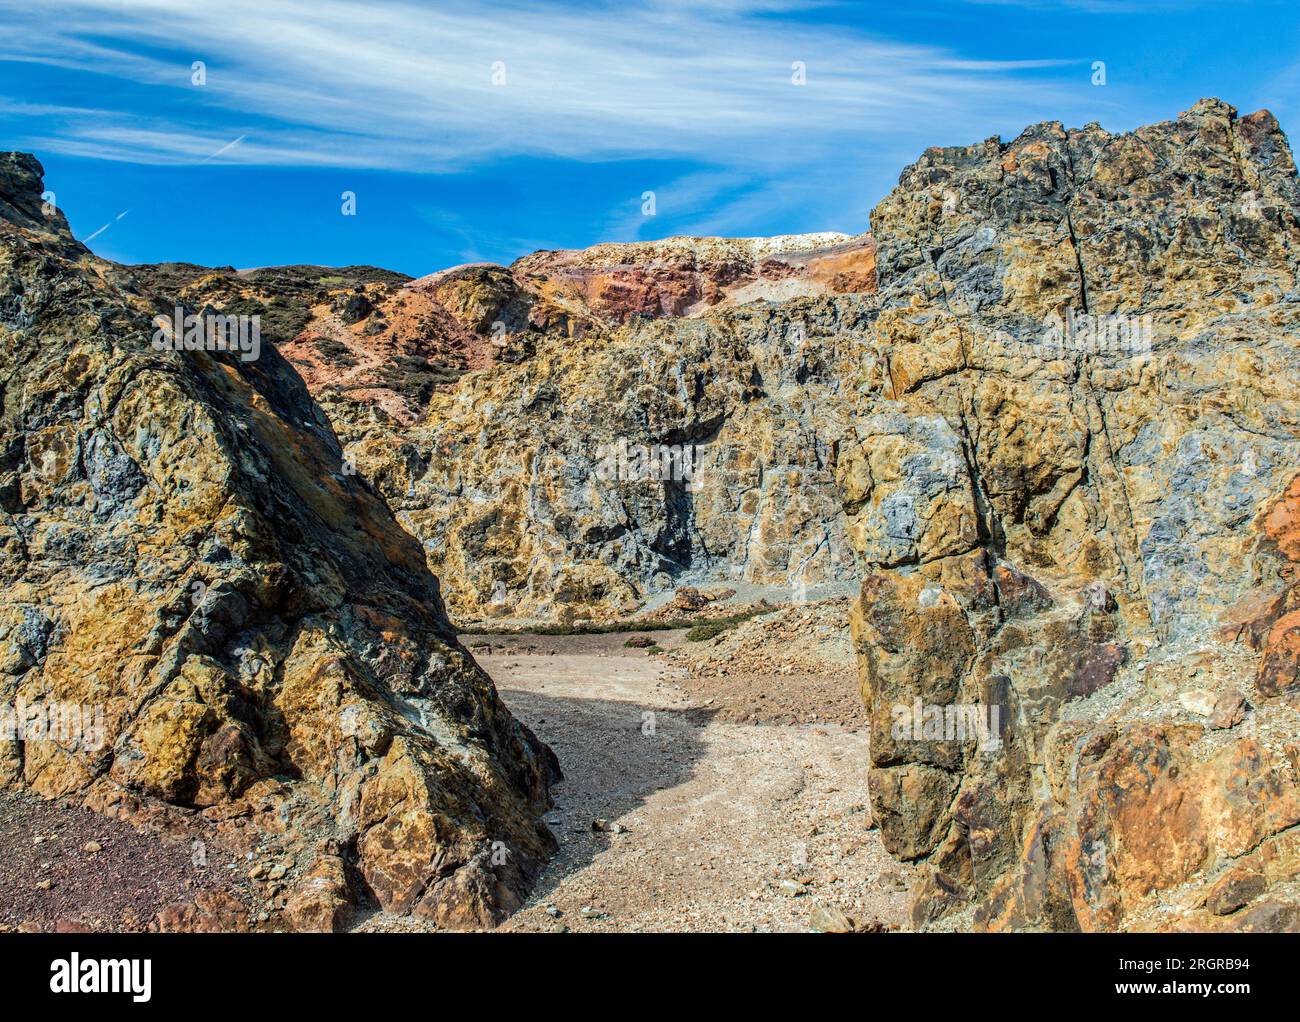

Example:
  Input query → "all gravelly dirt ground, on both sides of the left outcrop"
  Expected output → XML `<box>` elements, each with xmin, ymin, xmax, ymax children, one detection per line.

<box><xmin>0</xmin><ymin>609</ymin><xmax>911</xmax><ymax>932</ymax></box>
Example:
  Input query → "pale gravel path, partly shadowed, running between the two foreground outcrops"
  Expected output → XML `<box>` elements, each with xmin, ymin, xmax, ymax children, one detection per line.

<box><xmin>469</xmin><ymin>632</ymin><xmax>910</xmax><ymax>931</ymax></box>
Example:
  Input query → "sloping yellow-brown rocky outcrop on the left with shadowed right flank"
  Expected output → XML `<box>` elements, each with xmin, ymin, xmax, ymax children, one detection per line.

<box><xmin>0</xmin><ymin>153</ymin><xmax>555</xmax><ymax>928</ymax></box>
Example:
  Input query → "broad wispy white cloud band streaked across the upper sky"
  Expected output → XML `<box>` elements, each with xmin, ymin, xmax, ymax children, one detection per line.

<box><xmin>0</xmin><ymin>0</ymin><xmax>1086</xmax><ymax>170</ymax></box>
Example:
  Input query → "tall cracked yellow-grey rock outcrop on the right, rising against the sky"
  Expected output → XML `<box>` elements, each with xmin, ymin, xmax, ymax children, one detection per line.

<box><xmin>837</xmin><ymin>100</ymin><xmax>1300</xmax><ymax>930</ymax></box>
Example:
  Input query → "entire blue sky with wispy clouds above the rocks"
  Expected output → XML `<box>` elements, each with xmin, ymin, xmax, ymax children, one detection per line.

<box><xmin>0</xmin><ymin>0</ymin><xmax>1300</xmax><ymax>276</ymax></box>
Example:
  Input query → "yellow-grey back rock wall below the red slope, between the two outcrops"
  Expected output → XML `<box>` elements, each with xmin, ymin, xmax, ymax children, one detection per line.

<box><xmin>361</xmin><ymin>291</ymin><xmax>863</xmax><ymax>620</ymax></box>
